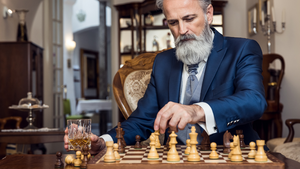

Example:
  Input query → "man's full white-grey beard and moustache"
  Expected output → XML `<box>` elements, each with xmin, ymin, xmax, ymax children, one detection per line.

<box><xmin>175</xmin><ymin>22</ymin><xmax>213</xmax><ymax>65</ymax></box>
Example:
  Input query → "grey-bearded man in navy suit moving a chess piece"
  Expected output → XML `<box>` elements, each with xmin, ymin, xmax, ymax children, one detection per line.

<box><xmin>65</xmin><ymin>0</ymin><xmax>267</xmax><ymax>153</ymax></box>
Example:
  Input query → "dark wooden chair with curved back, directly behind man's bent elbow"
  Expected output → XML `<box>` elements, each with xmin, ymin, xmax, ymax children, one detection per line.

<box><xmin>256</xmin><ymin>54</ymin><xmax>285</xmax><ymax>141</ymax></box>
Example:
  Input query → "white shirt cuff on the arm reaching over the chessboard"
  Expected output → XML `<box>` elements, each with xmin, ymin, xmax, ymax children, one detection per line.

<box><xmin>195</xmin><ymin>102</ymin><xmax>217</xmax><ymax>135</ymax></box>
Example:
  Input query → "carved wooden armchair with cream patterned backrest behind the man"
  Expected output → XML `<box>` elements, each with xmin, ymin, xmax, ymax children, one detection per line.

<box><xmin>113</xmin><ymin>50</ymin><xmax>169</xmax><ymax>145</ymax></box>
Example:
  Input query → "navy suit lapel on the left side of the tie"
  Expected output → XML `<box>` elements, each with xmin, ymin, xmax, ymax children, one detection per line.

<box><xmin>169</xmin><ymin>59</ymin><xmax>183</xmax><ymax>103</ymax></box>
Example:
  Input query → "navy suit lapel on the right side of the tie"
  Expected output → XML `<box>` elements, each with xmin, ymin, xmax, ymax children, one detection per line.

<box><xmin>200</xmin><ymin>28</ymin><xmax>227</xmax><ymax>101</ymax></box>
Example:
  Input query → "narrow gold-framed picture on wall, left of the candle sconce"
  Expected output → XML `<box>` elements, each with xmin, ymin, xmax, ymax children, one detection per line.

<box><xmin>248</xmin><ymin>4</ymin><xmax>259</xmax><ymax>36</ymax></box>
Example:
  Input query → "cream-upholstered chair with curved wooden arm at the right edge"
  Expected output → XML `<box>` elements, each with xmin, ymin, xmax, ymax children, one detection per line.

<box><xmin>267</xmin><ymin>119</ymin><xmax>300</xmax><ymax>162</ymax></box>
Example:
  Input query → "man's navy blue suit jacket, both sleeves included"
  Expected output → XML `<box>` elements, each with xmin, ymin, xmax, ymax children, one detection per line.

<box><xmin>108</xmin><ymin>28</ymin><xmax>267</xmax><ymax>145</ymax></box>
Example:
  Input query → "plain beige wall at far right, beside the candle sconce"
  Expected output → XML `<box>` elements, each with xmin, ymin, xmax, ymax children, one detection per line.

<box><xmin>273</xmin><ymin>0</ymin><xmax>300</xmax><ymax>137</ymax></box>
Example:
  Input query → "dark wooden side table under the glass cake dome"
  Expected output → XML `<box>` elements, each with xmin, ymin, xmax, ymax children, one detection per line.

<box><xmin>0</xmin><ymin>131</ymin><xmax>65</xmax><ymax>158</ymax></box>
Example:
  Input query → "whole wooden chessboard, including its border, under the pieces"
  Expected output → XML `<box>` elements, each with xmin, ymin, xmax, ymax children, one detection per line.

<box><xmin>87</xmin><ymin>145</ymin><xmax>284</xmax><ymax>169</ymax></box>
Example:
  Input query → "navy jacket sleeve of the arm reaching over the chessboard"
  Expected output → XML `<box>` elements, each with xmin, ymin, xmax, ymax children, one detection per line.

<box><xmin>205</xmin><ymin>40</ymin><xmax>267</xmax><ymax>133</ymax></box>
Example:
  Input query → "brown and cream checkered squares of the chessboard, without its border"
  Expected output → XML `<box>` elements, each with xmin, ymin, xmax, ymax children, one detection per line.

<box><xmin>97</xmin><ymin>145</ymin><xmax>273</xmax><ymax>164</ymax></box>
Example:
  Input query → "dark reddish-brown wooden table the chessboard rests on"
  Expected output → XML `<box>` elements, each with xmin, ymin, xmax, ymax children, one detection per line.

<box><xmin>0</xmin><ymin>153</ymin><xmax>300</xmax><ymax>169</ymax></box>
